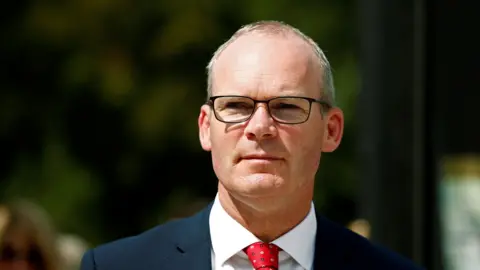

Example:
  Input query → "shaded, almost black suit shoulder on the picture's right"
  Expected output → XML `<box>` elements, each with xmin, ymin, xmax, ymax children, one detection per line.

<box><xmin>320</xmin><ymin>218</ymin><xmax>422</xmax><ymax>270</ymax></box>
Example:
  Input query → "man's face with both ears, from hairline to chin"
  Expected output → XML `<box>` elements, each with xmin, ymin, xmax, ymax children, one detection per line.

<box><xmin>199</xmin><ymin>34</ymin><xmax>343</xmax><ymax>202</ymax></box>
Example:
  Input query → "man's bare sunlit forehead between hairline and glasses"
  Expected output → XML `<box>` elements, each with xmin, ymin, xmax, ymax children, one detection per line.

<box><xmin>212</xmin><ymin>34</ymin><xmax>321</xmax><ymax>98</ymax></box>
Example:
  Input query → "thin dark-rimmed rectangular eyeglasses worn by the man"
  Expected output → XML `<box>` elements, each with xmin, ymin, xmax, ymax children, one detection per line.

<box><xmin>207</xmin><ymin>96</ymin><xmax>331</xmax><ymax>125</ymax></box>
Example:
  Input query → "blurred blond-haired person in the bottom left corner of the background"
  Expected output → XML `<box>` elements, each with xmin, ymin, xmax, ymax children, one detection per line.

<box><xmin>0</xmin><ymin>200</ymin><xmax>62</xmax><ymax>270</ymax></box>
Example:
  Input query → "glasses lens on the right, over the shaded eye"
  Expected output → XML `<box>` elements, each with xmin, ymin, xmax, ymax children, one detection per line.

<box><xmin>269</xmin><ymin>97</ymin><xmax>310</xmax><ymax>124</ymax></box>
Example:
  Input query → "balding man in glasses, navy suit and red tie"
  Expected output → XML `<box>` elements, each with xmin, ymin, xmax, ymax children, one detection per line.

<box><xmin>81</xmin><ymin>21</ymin><xmax>424</xmax><ymax>270</ymax></box>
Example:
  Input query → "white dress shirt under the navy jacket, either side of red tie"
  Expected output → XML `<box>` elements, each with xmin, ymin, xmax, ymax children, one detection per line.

<box><xmin>209</xmin><ymin>195</ymin><xmax>317</xmax><ymax>270</ymax></box>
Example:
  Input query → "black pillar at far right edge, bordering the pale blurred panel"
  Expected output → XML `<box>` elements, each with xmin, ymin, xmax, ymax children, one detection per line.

<box><xmin>426</xmin><ymin>0</ymin><xmax>480</xmax><ymax>269</ymax></box>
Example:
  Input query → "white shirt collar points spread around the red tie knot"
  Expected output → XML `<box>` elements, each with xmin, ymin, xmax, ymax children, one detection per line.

<box><xmin>209</xmin><ymin>194</ymin><xmax>317</xmax><ymax>269</ymax></box>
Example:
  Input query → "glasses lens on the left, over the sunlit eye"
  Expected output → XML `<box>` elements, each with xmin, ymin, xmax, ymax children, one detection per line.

<box><xmin>213</xmin><ymin>97</ymin><xmax>255</xmax><ymax>123</ymax></box>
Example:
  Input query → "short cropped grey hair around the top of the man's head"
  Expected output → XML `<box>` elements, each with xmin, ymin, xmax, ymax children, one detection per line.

<box><xmin>207</xmin><ymin>21</ymin><xmax>335</xmax><ymax>106</ymax></box>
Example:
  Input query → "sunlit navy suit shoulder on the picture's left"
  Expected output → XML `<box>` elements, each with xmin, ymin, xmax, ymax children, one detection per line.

<box><xmin>81</xmin><ymin>205</ymin><xmax>208</xmax><ymax>270</ymax></box>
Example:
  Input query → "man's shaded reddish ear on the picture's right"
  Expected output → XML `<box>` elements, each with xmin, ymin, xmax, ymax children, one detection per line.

<box><xmin>322</xmin><ymin>107</ymin><xmax>344</xmax><ymax>152</ymax></box>
